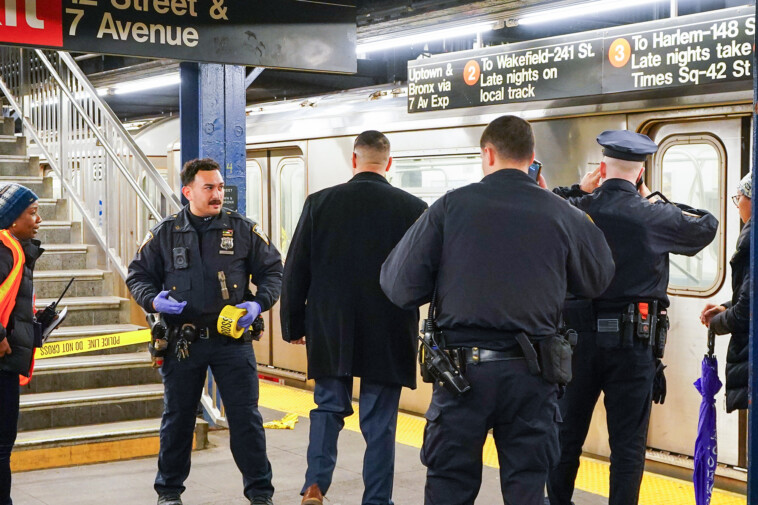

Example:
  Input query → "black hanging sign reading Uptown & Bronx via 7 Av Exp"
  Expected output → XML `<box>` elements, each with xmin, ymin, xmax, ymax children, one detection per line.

<box><xmin>408</xmin><ymin>7</ymin><xmax>755</xmax><ymax>112</ymax></box>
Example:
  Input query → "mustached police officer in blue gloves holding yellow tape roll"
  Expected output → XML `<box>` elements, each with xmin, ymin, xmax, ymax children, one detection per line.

<box><xmin>126</xmin><ymin>158</ymin><xmax>282</xmax><ymax>505</ymax></box>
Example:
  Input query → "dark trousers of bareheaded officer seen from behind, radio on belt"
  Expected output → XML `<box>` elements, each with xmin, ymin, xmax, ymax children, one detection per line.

<box><xmin>421</xmin><ymin>359</ymin><xmax>560</xmax><ymax>505</ymax></box>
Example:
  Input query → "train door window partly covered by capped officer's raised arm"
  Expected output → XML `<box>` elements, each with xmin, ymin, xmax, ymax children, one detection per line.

<box><xmin>658</xmin><ymin>135</ymin><xmax>725</xmax><ymax>296</ymax></box>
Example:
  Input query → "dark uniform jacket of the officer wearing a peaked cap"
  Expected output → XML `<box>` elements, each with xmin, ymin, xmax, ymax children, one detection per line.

<box><xmin>553</xmin><ymin>179</ymin><xmax>719</xmax><ymax>309</ymax></box>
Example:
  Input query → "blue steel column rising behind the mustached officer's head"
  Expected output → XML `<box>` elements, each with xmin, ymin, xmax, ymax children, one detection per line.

<box><xmin>179</xmin><ymin>63</ymin><xmax>247</xmax><ymax>214</ymax></box>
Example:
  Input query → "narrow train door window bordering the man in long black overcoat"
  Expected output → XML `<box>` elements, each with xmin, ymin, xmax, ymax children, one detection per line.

<box><xmin>279</xmin><ymin>158</ymin><xmax>305</xmax><ymax>256</ymax></box>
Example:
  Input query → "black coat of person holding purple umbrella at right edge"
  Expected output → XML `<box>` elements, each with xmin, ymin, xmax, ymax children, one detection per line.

<box><xmin>711</xmin><ymin>219</ymin><xmax>753</xmax><ymax>412</ymax></box>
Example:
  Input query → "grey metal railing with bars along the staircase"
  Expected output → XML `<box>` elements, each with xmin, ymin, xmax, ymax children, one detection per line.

<box><xmin>0</xmin><ymin>47</ymin><xmax>181</xmax><ymax>279</ymax></box>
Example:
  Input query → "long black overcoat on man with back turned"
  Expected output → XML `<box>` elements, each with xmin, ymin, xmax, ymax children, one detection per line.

<box><xmin>281</xmin><ymin>172</ymin><xmax>426</xmax><ymax>387</ymax></box>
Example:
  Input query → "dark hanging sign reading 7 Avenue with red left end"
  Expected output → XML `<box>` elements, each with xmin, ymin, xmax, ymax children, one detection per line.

<box><xmin>0</xmin><ymin>0</ymin><xmax>357</xmax><ymax>73</ymax></box>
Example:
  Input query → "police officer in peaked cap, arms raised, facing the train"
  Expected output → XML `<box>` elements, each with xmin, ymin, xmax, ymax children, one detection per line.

<box><xmin>548</xmin><ymin>130</ymin><xmax>718</xmax><ymax>505</ymax></box>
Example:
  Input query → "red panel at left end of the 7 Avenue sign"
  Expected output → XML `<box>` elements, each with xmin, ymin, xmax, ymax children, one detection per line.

<box><xmin>0</xmin><ymin>0</ymin><xmax>63</xmax><ymax>47</ymax></box>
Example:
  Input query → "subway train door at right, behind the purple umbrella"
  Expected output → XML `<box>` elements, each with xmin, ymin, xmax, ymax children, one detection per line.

<box><xmin>646</xmin><ymin>116</ymin><xmax>750</xmax><ymax>465</ymax></box>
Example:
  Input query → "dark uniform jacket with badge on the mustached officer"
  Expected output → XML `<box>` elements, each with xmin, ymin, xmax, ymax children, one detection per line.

<box><xmin>126</xmin><ymin>206</ymin><xmax>282</xmax><ymax>328</ymax></box>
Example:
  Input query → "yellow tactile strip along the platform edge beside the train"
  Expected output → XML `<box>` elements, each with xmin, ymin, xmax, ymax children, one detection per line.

<box><xmin>259</xmin><ymin>381</ymin><xmax>747</xmax><ymax>505</ymax></box>
